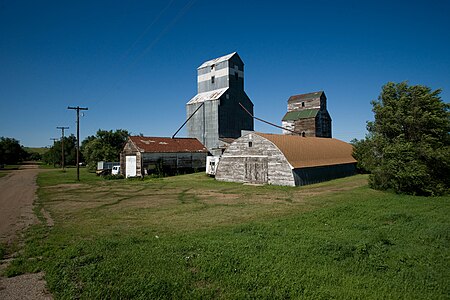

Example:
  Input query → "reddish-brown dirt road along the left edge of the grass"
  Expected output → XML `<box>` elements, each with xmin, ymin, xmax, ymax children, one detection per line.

<box><xmin>0</xmin><ymin>165</ymin><xmax>52</xmax><ymax>299</ymax></box>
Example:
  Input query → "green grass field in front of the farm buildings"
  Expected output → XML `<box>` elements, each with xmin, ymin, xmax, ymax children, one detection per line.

<box><xmin>7</xmin><ymin>169</ymin><xmax>450</xmax><ymax>299</ymax></box>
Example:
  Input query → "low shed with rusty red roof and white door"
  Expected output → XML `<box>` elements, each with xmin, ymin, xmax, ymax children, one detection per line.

<box><xmin>120</xmin><ymin>136</ymin><xmax>208</xmax><ymax>177</ymax></box>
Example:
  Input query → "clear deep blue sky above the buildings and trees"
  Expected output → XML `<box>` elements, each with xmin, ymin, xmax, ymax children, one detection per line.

<box><xmin>0</xmin><ymin>0</ymin><xmax>450</xmax><ymax>147</ymax></box>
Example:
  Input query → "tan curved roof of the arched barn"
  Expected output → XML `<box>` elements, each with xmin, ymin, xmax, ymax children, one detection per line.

<box><xmin>255</xmin><ymin>133</ymin><xmax>356</xmax><ymax>168</ymax></box>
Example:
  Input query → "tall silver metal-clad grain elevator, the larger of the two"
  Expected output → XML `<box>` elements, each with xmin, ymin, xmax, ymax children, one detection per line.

<box><xmin>186</xmin><ymin>52</ymin><xmax>253</xmax><ymax>154</ymax></box>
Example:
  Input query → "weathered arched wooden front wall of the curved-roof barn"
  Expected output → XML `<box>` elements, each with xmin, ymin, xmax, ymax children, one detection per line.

<box><xmin>216</xmin><ymin>133</ymin><xmax>295</xmax><ymax>186</ymax></box>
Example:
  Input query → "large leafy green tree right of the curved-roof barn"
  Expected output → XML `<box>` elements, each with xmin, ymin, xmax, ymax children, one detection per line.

<box><xmin>355</xmin><ymin>82</ymin><xmax>450</xmax><ymax>195</ymax></box>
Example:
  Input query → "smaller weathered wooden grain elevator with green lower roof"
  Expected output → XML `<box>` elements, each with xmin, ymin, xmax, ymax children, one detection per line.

<box><xmin>282</xmin><ymin>91</ymin><xmax>331</xmax><ymax>138</ymax></box>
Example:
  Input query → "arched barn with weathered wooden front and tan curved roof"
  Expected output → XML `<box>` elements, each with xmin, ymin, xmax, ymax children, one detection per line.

<box><xmin>216</xmin><ymin>132</ymin><xmax>356</xmax><ymax>186</ymax></box>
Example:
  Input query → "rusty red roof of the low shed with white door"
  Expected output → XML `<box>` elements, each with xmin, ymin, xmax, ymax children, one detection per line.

<box><xmin>129</xmin><ymin>136</ymin><xmax>208</xmax><ymax>153</ymax></box>
